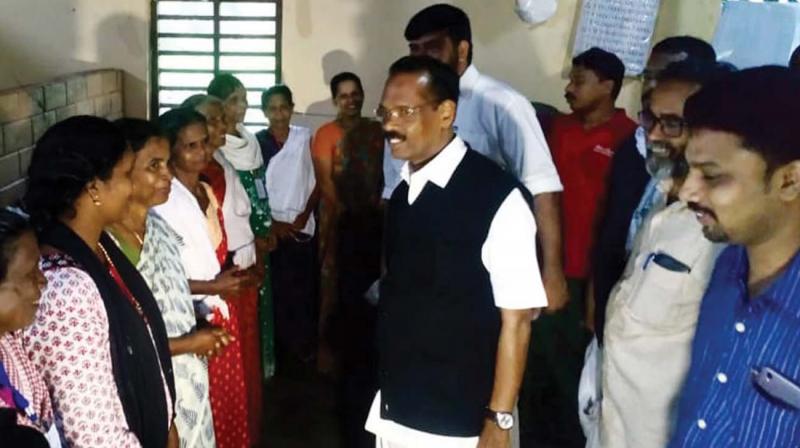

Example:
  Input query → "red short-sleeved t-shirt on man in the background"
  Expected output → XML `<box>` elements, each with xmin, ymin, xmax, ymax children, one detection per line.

<box><xmin>548</xmin><ymin>110</ymin><xmax>636</xmax><ymax>278</ymax></box>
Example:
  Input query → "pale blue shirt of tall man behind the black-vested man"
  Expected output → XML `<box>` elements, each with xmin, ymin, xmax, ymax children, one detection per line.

<box><xmin>383</xmin><ymin>65</ymin><xmax>563</xmax><ymax>198</ymax></box>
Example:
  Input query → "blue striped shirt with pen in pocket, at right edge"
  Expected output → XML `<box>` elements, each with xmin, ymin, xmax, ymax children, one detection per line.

<box><xmin>669</xmin><ymin>246</ymin><xmax>800</xmax><ymax>448</ymax></box>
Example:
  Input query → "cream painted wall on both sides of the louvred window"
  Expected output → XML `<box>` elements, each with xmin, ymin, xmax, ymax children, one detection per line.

<box><xmin>0</xmin><ymin>0</ymin><xmax>720</xmax><ymax>124</ymax></box>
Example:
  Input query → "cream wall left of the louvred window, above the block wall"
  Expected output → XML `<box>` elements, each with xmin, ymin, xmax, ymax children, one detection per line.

<box><xmin>0</xmin><ymin>0</ymin><xmax>150</xmax><ymax>117</ymax></box>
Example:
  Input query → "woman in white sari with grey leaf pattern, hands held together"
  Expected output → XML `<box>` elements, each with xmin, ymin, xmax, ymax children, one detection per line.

<box><xmin>109</xmin><ymin>118</ymin><xmax>230</xmax><ymax>448</ymax></box>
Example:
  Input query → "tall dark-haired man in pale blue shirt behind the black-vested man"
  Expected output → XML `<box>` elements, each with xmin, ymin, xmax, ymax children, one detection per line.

<box><xmin>383</xmin><ymin>4</ymin><xmax>568</xmax><ymax>311</ymax></box>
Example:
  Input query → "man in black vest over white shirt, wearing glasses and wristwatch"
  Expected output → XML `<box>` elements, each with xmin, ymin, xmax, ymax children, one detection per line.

<box><xmin>366</xmin><ymin>56</ymin><xmax>547</xmax><ymax>448</ymax></box>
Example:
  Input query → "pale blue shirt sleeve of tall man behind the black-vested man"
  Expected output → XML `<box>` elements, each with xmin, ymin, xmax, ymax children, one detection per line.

<box><xmin>496</xmin><ymin>94</ymin><xmax>564</xmax><ymax>196</ymax></box>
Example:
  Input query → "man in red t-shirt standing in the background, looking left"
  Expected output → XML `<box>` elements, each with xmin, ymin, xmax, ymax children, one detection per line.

<box><xmin>520</xmin><ymin>48</ymin><xmax>636</xmax><ymax>447</ymax></box>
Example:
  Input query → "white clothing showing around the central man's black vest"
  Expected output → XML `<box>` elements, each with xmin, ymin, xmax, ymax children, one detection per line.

<box><xmin>366</xmin><ymin>137</ymin><xmax>547</xmax><ymax>448</ymax></box>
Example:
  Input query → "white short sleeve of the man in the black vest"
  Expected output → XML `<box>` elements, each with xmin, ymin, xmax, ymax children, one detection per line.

<box><xmin>481</xmin><ymin>189</ymin><xmax>547</xmax><ymax>309</ymax></box>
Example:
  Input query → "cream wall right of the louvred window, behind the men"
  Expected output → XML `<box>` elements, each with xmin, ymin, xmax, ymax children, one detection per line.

<box><xmin>283</xmin><ymin>0</ymin><xmax>721</xmax><ymax>130</ymax></box>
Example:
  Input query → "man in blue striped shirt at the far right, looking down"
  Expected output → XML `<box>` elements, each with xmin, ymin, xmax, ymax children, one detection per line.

<box><xmin>670</xmin><ymin>67</ymin><xmax>800</xmax><ymax>448</ymax></box>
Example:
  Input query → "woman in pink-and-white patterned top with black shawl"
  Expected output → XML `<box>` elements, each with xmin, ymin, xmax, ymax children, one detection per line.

<box><xmin>23</xmin><ymin>116</ymin><xmax>177</xmax><ymax>448</ymax></box>
